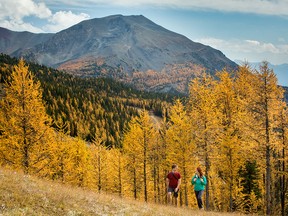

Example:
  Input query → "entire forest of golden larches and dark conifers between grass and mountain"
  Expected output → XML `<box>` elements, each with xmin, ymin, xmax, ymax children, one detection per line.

<box><xmin>0</xmin><ymin>56</ymin><xmax>288</xmax><ymax>216</ymax></box>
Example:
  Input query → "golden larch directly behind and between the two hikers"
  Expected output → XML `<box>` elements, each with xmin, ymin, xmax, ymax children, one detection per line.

<box><xmin>166</xmin><ymin>99</ymin><xmax>197</xmax><ymax>206</ymax></box>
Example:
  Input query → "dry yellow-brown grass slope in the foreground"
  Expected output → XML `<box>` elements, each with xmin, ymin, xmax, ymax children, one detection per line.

<box><xmin>0</xmin><ymin>169</ymin><xmax>243</xmax><ymax>216</ymax></box>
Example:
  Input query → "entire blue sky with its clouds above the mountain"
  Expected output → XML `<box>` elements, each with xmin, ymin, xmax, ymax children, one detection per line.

<box><xmin>0</xmin><ymin>0</ymin><xmax>288</xmax><ymax>64</ymax></box>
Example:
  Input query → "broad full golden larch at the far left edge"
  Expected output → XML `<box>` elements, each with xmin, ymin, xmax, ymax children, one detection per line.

<box><xmin>0</xmin><ymin>60</ymin><xmax>53</xmax><ymax>173</ymax></box>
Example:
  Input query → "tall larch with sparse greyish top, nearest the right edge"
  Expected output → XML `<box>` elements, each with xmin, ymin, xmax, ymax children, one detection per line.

<box><xmin>250</xmin><ymin>62</ymin><xmax>283</xmax><ymax>215</ymax></box>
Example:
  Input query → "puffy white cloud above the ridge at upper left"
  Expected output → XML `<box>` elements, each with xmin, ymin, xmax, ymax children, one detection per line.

<box><xmin>0</xmin><ymin>0</ymin><xmax>89</xmax><ymax>33</ymax></box>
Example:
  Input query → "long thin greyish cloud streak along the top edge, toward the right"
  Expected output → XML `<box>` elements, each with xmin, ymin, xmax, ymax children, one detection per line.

<box><xmin>49</xmin><ymin>0</ymin><xmax>288</xmax><ymax>16</ymax></box>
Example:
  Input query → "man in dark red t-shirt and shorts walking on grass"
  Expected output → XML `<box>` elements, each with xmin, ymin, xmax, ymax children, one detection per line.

<box><xmin>166</xmin><ymin>164</ymin><xmax>181</xmax><ymax>205</ymax></box>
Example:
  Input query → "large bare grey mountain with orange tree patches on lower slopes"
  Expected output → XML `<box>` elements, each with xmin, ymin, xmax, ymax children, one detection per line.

<box><xmin>0</xmin><ymin>15</ymin><xmax>237</xmax><ymax>92</ymax></box>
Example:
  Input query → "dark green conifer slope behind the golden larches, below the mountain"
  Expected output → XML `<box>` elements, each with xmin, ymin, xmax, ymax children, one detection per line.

<box><xmin>0</xmin><ymin>54</ymin><xmax>176</xmax><ymax>147</ymax></box>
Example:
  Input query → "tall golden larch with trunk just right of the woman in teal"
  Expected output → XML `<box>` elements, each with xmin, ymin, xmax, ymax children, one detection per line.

<box><xmin>187</xmin><ymin>74</ymin><xmax>220</xmax><ymax>210</ymax></box>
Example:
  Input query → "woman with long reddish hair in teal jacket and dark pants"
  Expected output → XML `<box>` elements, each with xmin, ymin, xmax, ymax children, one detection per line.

<box><xmin>191</xmin><ymin>167</ymin><xmax>207</xmax><ymax>210</ymax></box>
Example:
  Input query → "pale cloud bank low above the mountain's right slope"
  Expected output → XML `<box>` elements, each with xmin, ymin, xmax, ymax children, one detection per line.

<box><xmin>196</xmin><ymin>38</ymin><xmax>288</xmax><ymax>64</ymax></box>
